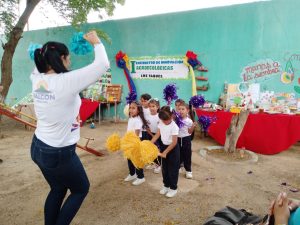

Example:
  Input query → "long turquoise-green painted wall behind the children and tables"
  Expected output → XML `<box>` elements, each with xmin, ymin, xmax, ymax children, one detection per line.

<box><xmin>0</xmin><ymin>0</ymin><xmax>300</xmax><ymax>116</ymax></box>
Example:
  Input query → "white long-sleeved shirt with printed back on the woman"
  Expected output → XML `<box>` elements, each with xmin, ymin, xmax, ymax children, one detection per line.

<box><xmin>30</xmin><ymin>43</ymin><xmax>109</xmax><ymax>147</ymax></box>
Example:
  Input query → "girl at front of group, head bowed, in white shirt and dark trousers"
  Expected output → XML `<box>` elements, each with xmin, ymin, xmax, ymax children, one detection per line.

<box><xmin>151</xmin><ymin>106</ymin><xmax>180</xmax><ymax>198</ymax></box>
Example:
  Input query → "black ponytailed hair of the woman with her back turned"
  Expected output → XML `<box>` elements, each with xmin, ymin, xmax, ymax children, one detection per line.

<box><xmin>34</xmin><ymin>41</ymin><xmax>69</xmax><ymax>73</ymax></box>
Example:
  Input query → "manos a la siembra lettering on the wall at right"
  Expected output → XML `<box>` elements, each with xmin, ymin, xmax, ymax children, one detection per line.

<box><xmin>241</xmin><ymin>59</ymin><xmax>281</xmax><ymax>83</ymax></box>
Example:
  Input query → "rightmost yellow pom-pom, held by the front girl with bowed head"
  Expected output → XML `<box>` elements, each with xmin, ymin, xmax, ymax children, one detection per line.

<box><xmin>140</xmin><ymin>140</ymin><xmax>158</xmax><ymax>165</ymax></box>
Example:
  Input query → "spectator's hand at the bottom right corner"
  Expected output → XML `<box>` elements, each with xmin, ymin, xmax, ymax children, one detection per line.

<box><xmin>273</xmin><ymin>192</ymin><xmax>290</xmax><ymax>225</ymax></box>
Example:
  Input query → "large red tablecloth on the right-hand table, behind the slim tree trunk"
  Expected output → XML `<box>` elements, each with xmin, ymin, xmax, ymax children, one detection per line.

<box><xmin>196</xmin><ymin>109</ymin><xmax>300</xmax><ymax>155</ymax></box>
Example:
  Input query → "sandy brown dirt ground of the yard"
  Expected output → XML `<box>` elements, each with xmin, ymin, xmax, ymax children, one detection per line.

<box><xmin>0</xmin><ymin>118</ymin><xmax>300</xmax><ymax>225</ymax></box>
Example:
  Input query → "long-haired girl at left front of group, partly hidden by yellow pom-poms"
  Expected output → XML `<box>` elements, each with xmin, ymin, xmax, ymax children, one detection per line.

<box><xmin>124</xmin><ymin>101</ymin><xmax>147</xmax><ymax>185</ymax></box>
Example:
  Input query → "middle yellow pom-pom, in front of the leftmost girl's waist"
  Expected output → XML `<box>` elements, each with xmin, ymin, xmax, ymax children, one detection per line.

<box><xmin>121</xmin><ymin>131</ymin><xmax>141</xmax><ymax>160</ymax></box>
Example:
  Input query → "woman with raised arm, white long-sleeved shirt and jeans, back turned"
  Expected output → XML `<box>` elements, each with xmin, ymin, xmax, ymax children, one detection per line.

<box><xmin>30</xmin><ymin>31</ymin><xmax>109</xmax><ymax>225</ymax></box>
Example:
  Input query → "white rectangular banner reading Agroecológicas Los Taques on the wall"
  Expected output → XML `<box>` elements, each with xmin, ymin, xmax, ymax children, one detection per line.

<box><xmin>130</xmin><ymin>57</ymin><xmax>189</xmax><ymax>79</ymax></box>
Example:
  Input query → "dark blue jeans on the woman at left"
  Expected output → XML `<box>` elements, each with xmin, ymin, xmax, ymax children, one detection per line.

<box><xmin>31</xmin><ymin>135</ymin><xmax>90</xmax><ymax>225</ymax></box>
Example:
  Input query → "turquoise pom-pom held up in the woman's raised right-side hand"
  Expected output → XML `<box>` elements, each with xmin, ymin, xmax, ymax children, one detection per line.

<box><xmin>70</xmin><ymin>32</ymin><xmax>93</xmax><ymax>55</ymax></box>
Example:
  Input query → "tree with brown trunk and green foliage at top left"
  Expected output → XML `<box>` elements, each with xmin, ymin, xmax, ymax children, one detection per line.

<box><xmin>0</xmin><ymin>0</ymin><xmax>125</xmax><ymax>99</ymax></box>
